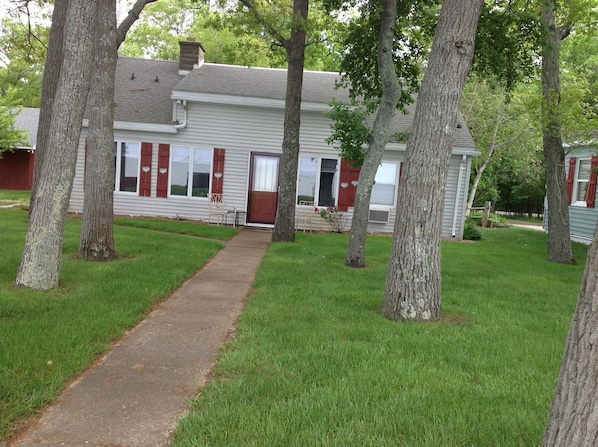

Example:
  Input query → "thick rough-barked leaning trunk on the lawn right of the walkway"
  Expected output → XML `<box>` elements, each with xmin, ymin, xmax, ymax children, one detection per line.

<box><xmin>382</xmin><ymin>0</ymin><xmax>483</xmax><ymax>321</ymax></box>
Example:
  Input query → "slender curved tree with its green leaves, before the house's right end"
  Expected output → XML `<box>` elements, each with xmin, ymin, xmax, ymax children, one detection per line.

<box><xmin>327</xmin><ymin>0</ymin><xmax>437</xmax><ymax>268</ymax></box>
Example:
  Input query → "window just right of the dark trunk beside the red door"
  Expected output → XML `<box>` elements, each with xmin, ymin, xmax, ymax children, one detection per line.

<box><xmin>297</xmin><ymin>157</ymin><xmax>339</xmax><ymax>206</ymax></box>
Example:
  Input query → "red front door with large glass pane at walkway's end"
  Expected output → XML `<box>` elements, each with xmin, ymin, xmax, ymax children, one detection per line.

<box><xmin>247</xmin><ymin>153</ymin><xmax>280</xmax><ymax>224</ymax></box>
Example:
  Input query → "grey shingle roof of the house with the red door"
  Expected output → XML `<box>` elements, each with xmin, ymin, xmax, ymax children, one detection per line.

<box><xmin>109</xmin><ymin>57</ymin><xmax>475</xmax><ymax>149</ymax></box>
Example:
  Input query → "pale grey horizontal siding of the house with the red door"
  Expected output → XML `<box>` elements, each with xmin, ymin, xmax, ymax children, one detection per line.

<box><xmin>69</xmin><ymin>86</ymin><xmax>471</xmax><ymax>239</ymax></box>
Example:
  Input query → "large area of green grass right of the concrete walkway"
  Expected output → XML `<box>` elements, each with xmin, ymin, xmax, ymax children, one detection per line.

<box><xmin>172</xmin><ymin>228</ymin><xmax>587</xmax><ymax>447</ymax></box>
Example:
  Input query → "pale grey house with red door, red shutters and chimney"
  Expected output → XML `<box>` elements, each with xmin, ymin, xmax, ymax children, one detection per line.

<box><xmin>69</xmin><ymin>41</ymin><xmax>478</xmax><ymax>239</ymax></box>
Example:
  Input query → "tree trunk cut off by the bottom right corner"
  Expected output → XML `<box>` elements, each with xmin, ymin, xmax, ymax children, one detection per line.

<box><xmin>542</xmin><ymin>222</ymin><xmax>598</xmax><ymax>447</ymax></box>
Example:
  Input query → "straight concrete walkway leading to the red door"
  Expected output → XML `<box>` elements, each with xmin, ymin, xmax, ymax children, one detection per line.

<box><xmin>1</xmin><ymin>229</ymin><xmax>272</xmax><ymax>447</ymax></box>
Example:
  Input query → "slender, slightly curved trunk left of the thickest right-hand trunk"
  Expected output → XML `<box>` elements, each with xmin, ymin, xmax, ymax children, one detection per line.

<box><xmin>345</xmin><ymin>0</ymin><xmax>401</xmax><ymax>267</ymax></box>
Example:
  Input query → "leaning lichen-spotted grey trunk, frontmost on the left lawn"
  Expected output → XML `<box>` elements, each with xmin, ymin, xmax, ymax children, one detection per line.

<box><xmin>16</xmin><ymin>0</ymin><xmax>96</xmax><ymax>290</ymax></box>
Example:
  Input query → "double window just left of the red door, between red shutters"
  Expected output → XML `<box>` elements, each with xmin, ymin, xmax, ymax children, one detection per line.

<box><xmin>170</xmin><ymin>146</ymin><xmax>212</xmax><ymax>197</ymax></box>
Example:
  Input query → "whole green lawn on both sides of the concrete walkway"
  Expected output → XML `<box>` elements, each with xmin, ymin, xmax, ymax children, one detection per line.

<box><xmin>0</xmin><ymin>200</ymin><xmax>587</xmax><ymax>447</ymax></box>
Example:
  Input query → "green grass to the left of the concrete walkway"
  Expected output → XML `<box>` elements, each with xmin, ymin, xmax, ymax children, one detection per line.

<box><xmin>0</xmin><ymin>207</ymin><xmax>237</xmax><ymax>439</ymax></box>
